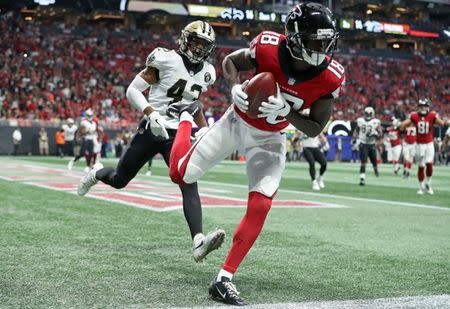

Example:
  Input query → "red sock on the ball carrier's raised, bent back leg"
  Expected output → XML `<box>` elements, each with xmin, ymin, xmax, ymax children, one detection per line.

<box><xmin>169</xmin><ymin>121</ymin><xmax>192</xmax><ymax>184</ymax></box>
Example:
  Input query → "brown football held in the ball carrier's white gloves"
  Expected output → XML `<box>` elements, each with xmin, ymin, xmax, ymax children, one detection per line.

<box><xmin>244</xmin><ymin>72</ymin><xmax>277</xmax><ymax>118</ymax></box>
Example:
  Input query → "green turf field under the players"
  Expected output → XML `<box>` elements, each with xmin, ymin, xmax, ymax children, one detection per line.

<box><xmin>0</xmin><ymin>157</ymin><xmax>450</xmax><ymax>308</ymax></box>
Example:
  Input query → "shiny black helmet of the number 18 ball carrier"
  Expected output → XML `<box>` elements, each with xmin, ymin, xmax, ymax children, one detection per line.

<box><xmin>285</xmin><ymin>2</ymin><xmax>339</xmax><ymax>66</ymax></box>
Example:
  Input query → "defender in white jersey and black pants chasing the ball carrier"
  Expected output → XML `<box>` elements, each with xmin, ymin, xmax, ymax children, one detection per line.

<box><xmin>78</xmin><ymin>21</ymin><xmax>225</xmax><ymax>262</ymax></box>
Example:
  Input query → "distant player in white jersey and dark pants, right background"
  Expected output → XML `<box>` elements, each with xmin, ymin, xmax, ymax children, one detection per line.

<box><xmin>354</xmin><ymin>106</ymin><xmax>382</xmax><ymax>186</ymax></box>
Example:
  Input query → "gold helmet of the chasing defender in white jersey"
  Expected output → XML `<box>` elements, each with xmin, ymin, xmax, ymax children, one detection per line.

<box><xmin>178</xmin><ymin>20</ymin><xmax>216</xmax><ymax>63</ymax></box>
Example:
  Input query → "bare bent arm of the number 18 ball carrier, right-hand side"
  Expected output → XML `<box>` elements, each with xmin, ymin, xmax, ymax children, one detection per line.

<box><xmin>286</xmin><ymin>99</ymin><xmax>334</xmax><ymax>137</ymax></box>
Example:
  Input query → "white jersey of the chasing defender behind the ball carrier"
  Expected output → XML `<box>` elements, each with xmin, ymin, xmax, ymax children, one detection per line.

<box><xmin>146</xmin><ymin>47</ymin><xmax>216</xmax><ymax>129</ymax></box>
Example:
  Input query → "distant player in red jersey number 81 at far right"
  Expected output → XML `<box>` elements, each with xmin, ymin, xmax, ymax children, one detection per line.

<box><xmin>400</xmin><ymin>98</ymin><xmax>445</xmax><ymax>195</ymax></box>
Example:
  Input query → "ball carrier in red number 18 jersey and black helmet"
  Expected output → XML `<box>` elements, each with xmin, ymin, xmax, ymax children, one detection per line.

<box><xmin>170</xmin><ymin>3</ymin><xmax>345</xmax><ymax>305</ymax></box>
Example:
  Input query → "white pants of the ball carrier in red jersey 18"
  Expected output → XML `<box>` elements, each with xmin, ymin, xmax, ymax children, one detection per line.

<box><xmin>179</xmin><ymin>105</ymin><xmax>286</xmax><ymax>197</ymax></box>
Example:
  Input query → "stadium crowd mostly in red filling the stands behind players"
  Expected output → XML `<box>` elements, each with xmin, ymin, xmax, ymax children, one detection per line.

<box><xmin>0</xmin><ymin>15</ymin><xmax>450</xmax><ymax>128</ymax></box>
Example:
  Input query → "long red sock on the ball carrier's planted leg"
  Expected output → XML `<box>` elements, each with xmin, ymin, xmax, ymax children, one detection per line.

<box><xmin>223</xmin><ymin>192</ymin><xmax>272</xmax><ymax>274</ymax></box>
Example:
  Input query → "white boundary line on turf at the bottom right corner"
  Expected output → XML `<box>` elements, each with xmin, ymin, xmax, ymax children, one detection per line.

<box><xmin>174</xmin><ymin>294</ymin><xmax>450</xmax><ymax>309</ymax></box>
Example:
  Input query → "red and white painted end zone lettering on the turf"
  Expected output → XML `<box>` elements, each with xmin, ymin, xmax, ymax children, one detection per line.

<box><xmin>0</xmin><ymin>163</ymin><xmax>347</xmax><ymax>211</ymax></box>
